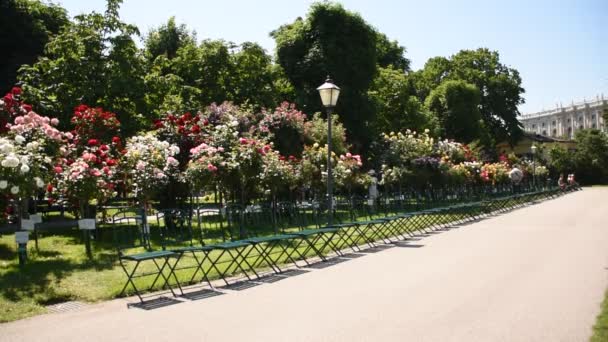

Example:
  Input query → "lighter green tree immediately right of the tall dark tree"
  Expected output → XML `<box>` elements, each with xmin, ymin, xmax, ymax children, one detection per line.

<box><xmin>368</xmin><ymin>66</ymin><xmax>435</xmax><ymax>134</ymax></box>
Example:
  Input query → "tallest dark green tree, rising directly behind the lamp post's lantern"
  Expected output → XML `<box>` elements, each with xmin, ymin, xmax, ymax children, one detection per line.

<box><xmin>271</xmin><ymin>2</ymin><xmax>377</xmax><ymax>150</ymax></box>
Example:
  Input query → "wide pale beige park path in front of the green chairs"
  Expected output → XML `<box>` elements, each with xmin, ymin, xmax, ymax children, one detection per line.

<box><xmin>0</xmin><ymin>188</ymin><xmax>608</xmax><ymax>342</ymax></box>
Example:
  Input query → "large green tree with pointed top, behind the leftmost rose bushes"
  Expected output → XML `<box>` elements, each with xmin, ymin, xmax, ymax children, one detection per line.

<box><xmin>19</xmin><ymin>0</ymin><xmax>144</xmax><ymax>135</ymax></box>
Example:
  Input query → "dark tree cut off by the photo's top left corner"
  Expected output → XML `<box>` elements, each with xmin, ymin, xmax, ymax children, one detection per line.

<box><xmin>0</xmin><ymin>0</ymin><xmax>69</xmax><ymax>94</ymax></box>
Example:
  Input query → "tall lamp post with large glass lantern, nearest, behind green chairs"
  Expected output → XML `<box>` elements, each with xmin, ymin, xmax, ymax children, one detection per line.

<box><xmin>317</xmin><ymin>76</ymin><xmax>340</xmax><ymax>226</ymax></box>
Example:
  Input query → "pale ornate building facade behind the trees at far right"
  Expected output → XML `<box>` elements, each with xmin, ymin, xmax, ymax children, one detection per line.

<box><xmin>519</xmin><ymin>94</ymin><xmax>608</xmax><ymax>139</ymax></box>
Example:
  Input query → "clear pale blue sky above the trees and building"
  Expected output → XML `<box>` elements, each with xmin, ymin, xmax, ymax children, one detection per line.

<box><xmin>58</xmin><ymin>0</ymin><xmax>608</xmax><ymax>113</ymax></box>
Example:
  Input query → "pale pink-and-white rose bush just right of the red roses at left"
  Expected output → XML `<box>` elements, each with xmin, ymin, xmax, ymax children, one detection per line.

<box><xmin>122</xmin><ymin>134</ymin><xmax>180</xmax><ymax>200</ymax></box>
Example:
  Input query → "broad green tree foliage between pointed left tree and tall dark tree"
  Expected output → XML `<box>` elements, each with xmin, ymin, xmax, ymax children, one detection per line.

<box><xmin>145</xmin><ymin>40</ymin><xmax>282</xmax><ymax>118</ymax></box>
